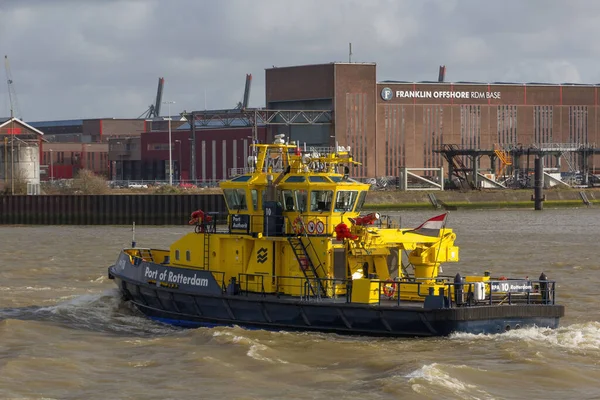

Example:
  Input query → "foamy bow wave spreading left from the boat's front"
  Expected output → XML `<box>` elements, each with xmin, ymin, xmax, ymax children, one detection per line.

<box><xmin>0</xmin><ymin>289</ymin><xmax>181</xmax><ymax>336</ymax></box>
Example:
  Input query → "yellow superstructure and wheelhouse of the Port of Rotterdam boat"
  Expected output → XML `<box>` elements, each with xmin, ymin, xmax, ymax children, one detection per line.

<box><xmin>155</xmin><ymin>136</ymin><xmax>474</xmax><ymax>303</ymax></box>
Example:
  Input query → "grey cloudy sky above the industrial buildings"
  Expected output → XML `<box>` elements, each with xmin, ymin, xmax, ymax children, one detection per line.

<box><xmin>0</xmin><ymin>0</ymin><xmax>600</xmax><ymax>121</ymax></box>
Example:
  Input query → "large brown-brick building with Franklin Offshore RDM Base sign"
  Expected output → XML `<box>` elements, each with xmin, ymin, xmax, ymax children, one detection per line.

<box><xmin>266</xmin><ymin>63</ymin><xmax>600</xmax><ymax>177</ymax></box>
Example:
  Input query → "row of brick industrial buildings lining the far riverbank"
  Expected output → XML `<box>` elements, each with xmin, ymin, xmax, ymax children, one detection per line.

<box><xmin>15</xmin><ymin>63</ymin><xmax>600</xmax><ymax>188</ymax></box>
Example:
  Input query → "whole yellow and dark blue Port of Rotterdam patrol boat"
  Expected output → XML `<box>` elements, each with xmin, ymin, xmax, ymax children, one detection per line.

<box><xmin>108</xmin><ymin>135</ymin><xmax>564</xmax><ymax>336</ymax></box>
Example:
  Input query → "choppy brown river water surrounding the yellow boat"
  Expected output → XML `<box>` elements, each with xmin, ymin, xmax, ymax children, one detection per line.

<box><xmin>0</xmin><ymin>208</ymin><xmax>600</xmax><ymax>399</ymax></box>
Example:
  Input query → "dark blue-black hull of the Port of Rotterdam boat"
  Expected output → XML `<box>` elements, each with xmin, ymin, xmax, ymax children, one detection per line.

<box><xmin>109</xmin><ymin>267</ymin><xmax>564</xmax><ymax>337</ymax></box>
